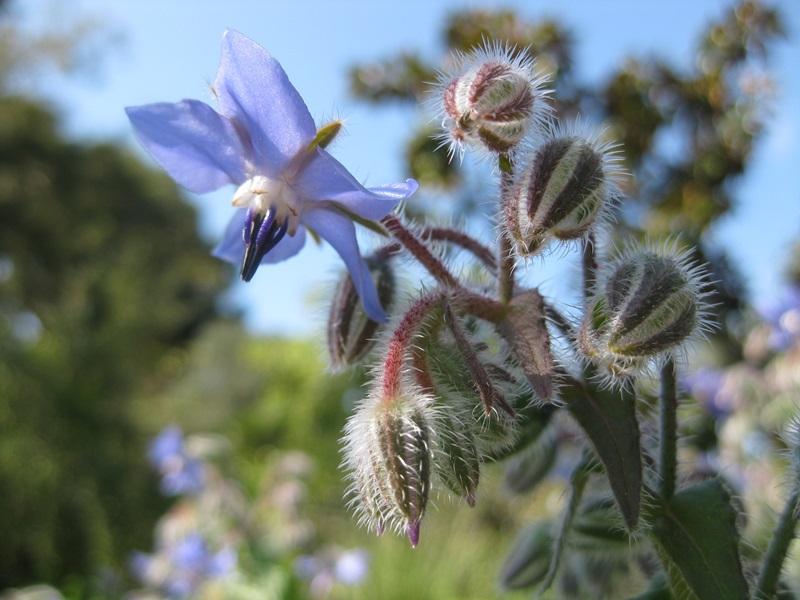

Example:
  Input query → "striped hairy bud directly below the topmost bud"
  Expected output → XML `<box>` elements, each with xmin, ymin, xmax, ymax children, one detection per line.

<box><xmin>503</xmin><ymin>125</ymin><xmax>620</xmax><ymax>256</ymax></box>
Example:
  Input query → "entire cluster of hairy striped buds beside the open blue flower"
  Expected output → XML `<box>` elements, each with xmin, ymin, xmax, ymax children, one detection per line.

<box><xmin>328</xmin><ymin>39</ymin><xmax>707</xmax><ymax>546</ymax></box>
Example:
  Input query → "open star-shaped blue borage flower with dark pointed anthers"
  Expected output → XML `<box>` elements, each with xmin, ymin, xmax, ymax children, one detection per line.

<box><xmin>126</xmin><ymin>30</ymin><xmax>417</xmax><ymax>321</ymax></box>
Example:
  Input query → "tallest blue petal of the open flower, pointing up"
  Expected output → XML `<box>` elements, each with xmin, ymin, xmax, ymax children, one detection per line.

<box><xmin>214</xmin><ymin>30</ymin><xmax>317</xmax><ymax>177</ymax></box>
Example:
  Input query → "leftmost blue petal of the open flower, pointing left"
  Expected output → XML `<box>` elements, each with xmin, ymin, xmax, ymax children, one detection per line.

<box><xmin>125</xmin><ymin>100</ymin><xmax>246</xmax><ymax>193</ymax></box>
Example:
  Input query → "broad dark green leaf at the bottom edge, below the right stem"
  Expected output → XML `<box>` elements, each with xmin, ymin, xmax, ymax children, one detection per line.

<box><xmin>646</xmin><ymin>479</ymin><xmax>748</xmax><ymax>600</ymax></box>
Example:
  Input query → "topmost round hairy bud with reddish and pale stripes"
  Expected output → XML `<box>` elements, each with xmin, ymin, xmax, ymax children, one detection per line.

<box><xmin>434</xmin><ymin>46</ymin><xmax>550</xmax><ymax>153</ymax></box>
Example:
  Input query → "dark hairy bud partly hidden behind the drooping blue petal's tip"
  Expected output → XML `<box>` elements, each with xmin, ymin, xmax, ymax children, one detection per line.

<box><xmin>327</xmin><ymin>253</ymin><xmax>397</xmax><ymax>369</ymax></box>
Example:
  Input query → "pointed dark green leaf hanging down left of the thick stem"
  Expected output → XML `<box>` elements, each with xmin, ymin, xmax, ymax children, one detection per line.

<box><xmin>562</xmin><ymin>372</ymin><xmax>642</xmax><ymax>529</ymax></box>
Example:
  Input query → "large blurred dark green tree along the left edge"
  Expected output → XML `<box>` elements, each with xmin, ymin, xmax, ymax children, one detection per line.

<box><xmin>0</xmin><ymin>97</ymin><xmax>227</xmax><ymax>589</ymax></box>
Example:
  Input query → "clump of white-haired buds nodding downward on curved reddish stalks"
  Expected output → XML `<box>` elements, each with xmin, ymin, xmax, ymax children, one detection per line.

<box><xmin>336</xmin><ymin>290</ymin><xmax>552</xmax><ymax>545</ymax></box>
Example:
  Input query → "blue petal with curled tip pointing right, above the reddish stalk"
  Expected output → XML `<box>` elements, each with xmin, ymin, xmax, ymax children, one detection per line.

<box><xmin>296</xmin><ymin>150</ymin><xmax>418</xmax><ymax>221</ymax></box>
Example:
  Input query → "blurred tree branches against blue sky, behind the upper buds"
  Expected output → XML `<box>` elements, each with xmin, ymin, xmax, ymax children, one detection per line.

<box><xmin>350</xmin><ymin>0</ymin><xmax>783</xmax><ymax>357</ymax></box>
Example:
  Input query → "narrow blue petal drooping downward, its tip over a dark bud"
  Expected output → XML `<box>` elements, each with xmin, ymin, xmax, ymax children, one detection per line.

<box><xmin>302</xmin><ymin>208</ymin><xmax>386</xmax><ymax>323</ymax></box>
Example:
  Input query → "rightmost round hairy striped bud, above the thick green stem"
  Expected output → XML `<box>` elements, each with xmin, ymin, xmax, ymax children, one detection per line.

<box><xmin>578</xmin><ymin>243</ymin><xmax>707</xmax><ymax>375</ymax></box>
